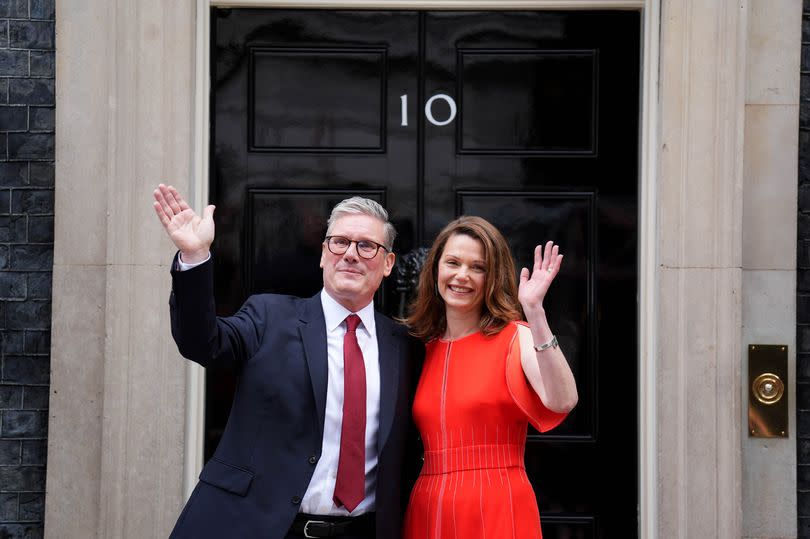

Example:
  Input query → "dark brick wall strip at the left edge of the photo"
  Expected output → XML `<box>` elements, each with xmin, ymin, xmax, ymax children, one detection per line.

<box><xmin>0</xmin><ymin>0</ymin><xmax>55</xmax><ymax>539</ymax></box>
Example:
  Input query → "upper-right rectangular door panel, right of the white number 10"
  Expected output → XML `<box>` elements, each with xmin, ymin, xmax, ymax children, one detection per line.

<box><xmin>456</xmin><ymin>47</ymin><xmax>599</xmax><ymax>156</ymax></box>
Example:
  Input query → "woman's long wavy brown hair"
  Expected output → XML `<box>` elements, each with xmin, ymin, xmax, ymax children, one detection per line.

<box><xmin>403</xmin><ymin>216</ymin><xmax>523</xmax><ymax>341</ymax></box>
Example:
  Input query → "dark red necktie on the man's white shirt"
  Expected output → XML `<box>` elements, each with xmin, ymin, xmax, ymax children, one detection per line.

<box><xmin>334</xmin><ymin>314</ymin><xmax>366</xmax><ymax>512</ymax></box>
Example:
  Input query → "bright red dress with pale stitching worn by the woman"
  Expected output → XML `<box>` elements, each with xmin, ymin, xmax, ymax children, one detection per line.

<box><xmin>403</xmin><ymin>323</ymin><xmax>566</xmax><ymax>539</ymax></box>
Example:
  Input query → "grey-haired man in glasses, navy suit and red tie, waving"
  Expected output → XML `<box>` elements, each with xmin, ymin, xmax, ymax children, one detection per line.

<box><xmin>154</xmin><ymin>184</ymin><xmax>415</xmax><ymax>539</ymax></box>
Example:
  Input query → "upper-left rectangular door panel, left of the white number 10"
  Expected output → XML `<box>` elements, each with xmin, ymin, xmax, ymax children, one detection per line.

<box><xmin>248</xmin><ymin>47</ymin><xmax>387</xmax><ymax>153</ymax></box>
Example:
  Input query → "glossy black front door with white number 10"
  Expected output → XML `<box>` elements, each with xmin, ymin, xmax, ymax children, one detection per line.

<box><xmin>205</xmin><ymin>9</ymin><xmax>641</xmax><ymax>539</ymax></box>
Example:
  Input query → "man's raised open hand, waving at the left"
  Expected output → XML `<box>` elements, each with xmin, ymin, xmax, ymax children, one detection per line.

<box><xmin>152</xmin><ymin>183</ymin><xmax>214</xmax><ymax>264</ymax></box>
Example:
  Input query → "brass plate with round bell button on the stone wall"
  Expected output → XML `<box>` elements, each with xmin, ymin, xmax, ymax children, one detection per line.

<box><xmin>747</xmin><ymin>344</ymin><xmax>788</xmax><ymax>438</ymax></box>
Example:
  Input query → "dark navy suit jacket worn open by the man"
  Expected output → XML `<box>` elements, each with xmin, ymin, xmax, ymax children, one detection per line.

<box><xmin>164</xmin><ymin>261</ymin><xmax>421</xmax><ymax>539</ymax></box>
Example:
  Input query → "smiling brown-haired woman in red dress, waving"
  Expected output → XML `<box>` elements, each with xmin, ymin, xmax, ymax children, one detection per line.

<box><xmin>404</xmin><ymin>217</ymin><xmax>577</xmax><ymax>539</ymax></box>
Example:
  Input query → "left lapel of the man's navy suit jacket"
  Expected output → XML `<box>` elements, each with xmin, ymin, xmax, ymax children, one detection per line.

<box><xmin>298</xmin><ymin>294</ymin><xmax>329</xmax><ymax>437</ymax></box>
